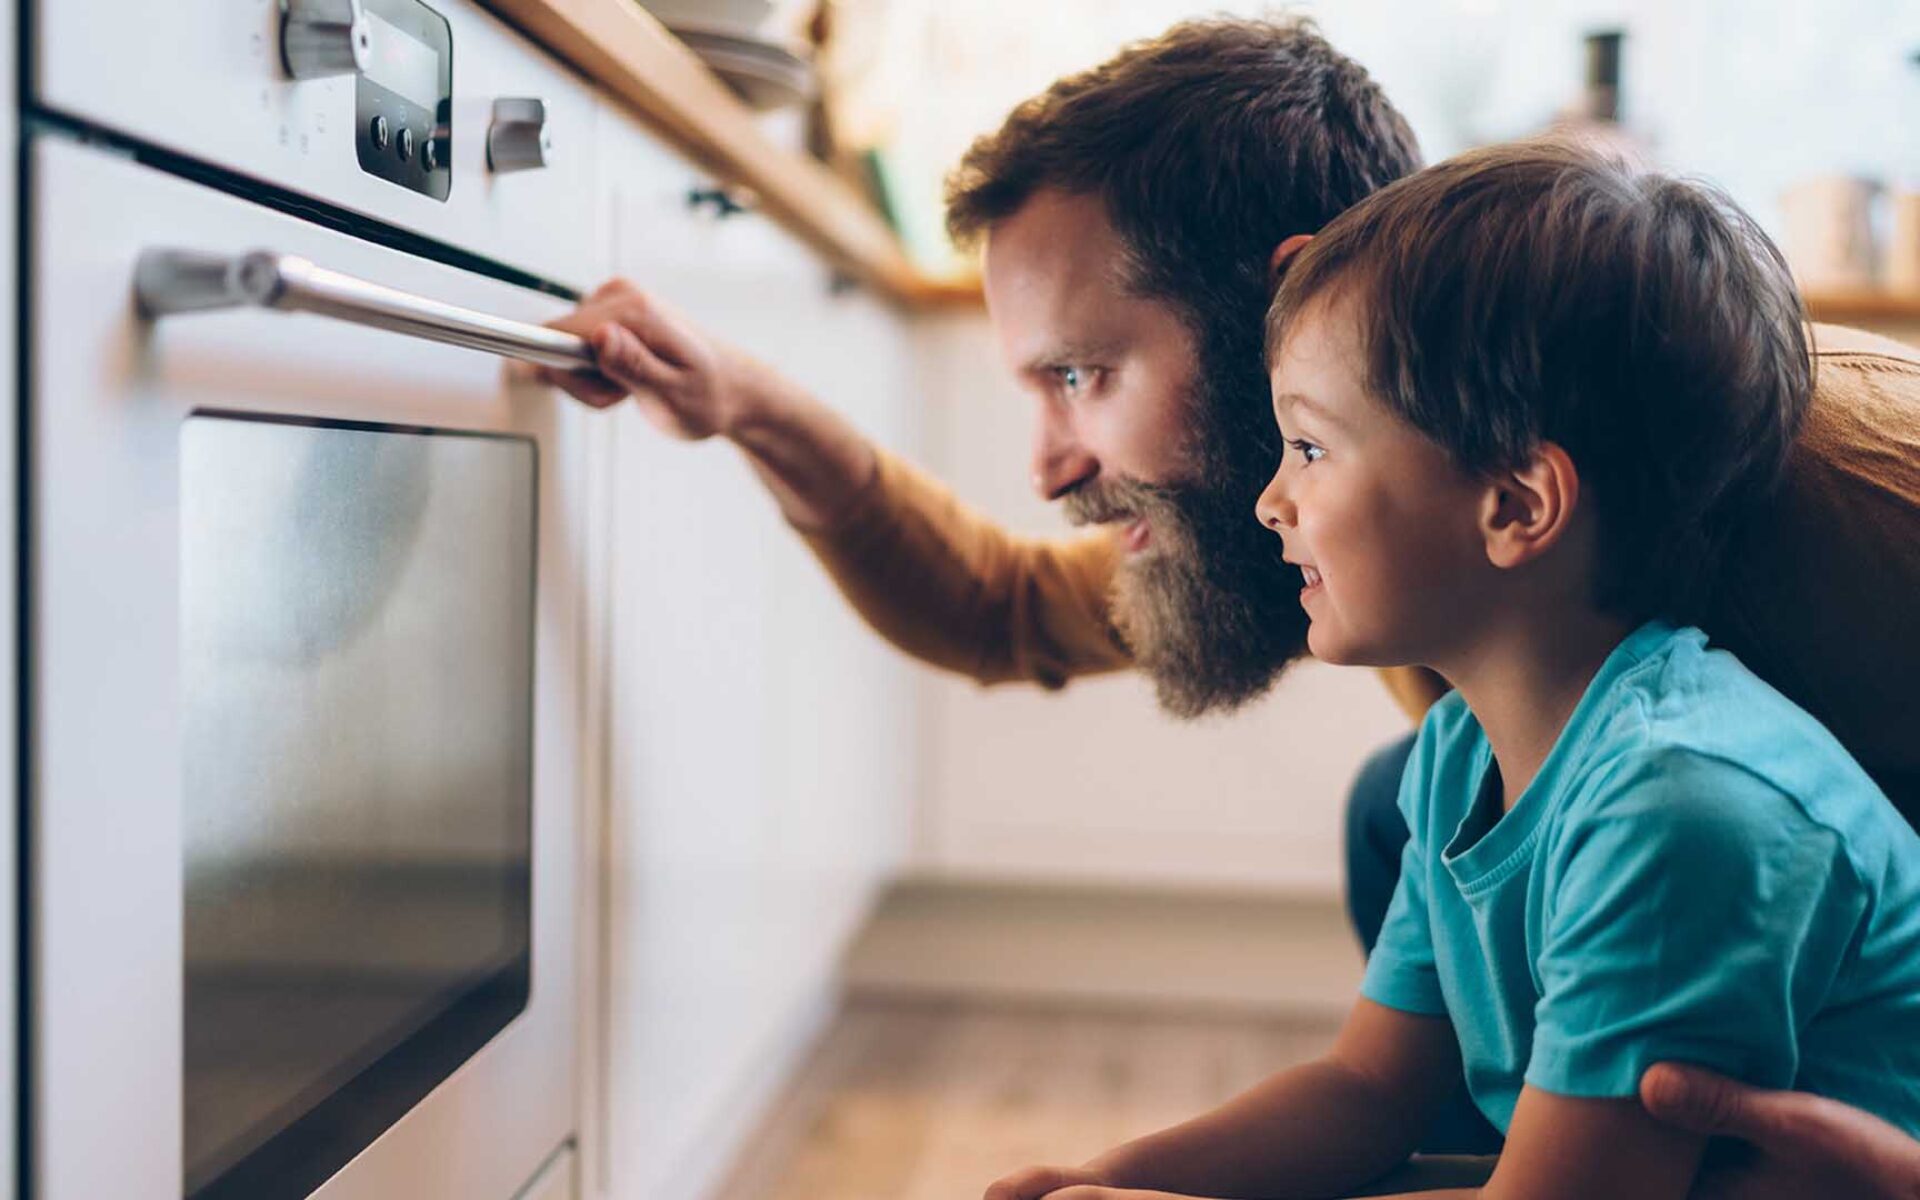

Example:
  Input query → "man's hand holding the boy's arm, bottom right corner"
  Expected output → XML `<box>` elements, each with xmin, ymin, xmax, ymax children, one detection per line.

<box><xmin>1640</xmin><ymin>1062</ymin><xmax>1920</xmax><ymax>1200</ymax></box>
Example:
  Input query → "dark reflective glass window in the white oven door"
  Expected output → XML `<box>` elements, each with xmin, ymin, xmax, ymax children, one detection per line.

<box><xmin>180</xmin><ymin>415</ymin><xmax>536</xmax><ymax>1200</ymax></box>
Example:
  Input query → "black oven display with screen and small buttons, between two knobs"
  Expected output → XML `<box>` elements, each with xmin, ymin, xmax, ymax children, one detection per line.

<box><xmin>353</xmin><ymin>0</ymin><xmax>453</xmax><ymax>200</ymax></box>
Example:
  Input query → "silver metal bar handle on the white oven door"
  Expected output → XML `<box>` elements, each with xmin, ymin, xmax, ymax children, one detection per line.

<box><xmin>132</xmin><ymin>248</ymin><xmax>593</xmax><ymax>371</ymax></box>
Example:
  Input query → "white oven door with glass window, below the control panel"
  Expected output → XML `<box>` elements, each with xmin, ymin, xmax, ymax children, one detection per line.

<box><xmin>27</xmin><ymin>138</ymin><xmax>580</xmax><ymax>1200</ymax></box>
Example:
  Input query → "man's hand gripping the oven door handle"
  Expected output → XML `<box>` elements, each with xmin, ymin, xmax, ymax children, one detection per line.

<box><xmin>540</xmin><ymin>278</ymin><xmax>764</xmax><ymax>440</ymax></box>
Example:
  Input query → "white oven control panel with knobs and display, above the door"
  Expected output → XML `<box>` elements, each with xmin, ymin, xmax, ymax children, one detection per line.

<box><xmin>45</xmin><ymin>0</ymin><xmax>605</xmax><ymax>288</ymax></box>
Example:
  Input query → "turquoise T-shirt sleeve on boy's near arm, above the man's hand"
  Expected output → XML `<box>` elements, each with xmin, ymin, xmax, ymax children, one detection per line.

<box><xmin>1526</xmin><ymin>753</ymin><xmax>1866</xmax><ymax>1096</ymax></box>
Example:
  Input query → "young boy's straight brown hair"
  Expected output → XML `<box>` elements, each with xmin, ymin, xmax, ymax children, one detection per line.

<box><xmin>1267</xmin><ymin>140</ymin><xmax>1812</xmax><ymax>620</ymax></box>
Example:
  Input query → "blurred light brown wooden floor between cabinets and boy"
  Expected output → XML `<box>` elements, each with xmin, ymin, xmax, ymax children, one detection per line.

<box><xmin>718</xmin><ymin>1000</ymin><xmax>1334</xmax><ymax>1200</ymax></box>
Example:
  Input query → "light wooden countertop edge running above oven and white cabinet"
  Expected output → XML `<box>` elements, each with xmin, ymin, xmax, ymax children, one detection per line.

<box><xmin>484</xmin><ymin>0</ymin><xmax>948</xmax><ymax>307</ymax></box>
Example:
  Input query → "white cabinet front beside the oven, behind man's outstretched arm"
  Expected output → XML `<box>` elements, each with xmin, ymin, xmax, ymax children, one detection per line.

<box><xmin>584</xmin><ymin>107</ymin><xmax>916</xmax><ymax>1200</ymax></box>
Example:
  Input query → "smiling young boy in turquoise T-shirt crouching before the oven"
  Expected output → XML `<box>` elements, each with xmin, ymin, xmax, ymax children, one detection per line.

<box><xmin>987</xmin><ymin>135</ymin><xmax>1920</xmax><ymax>1200</ymax></box>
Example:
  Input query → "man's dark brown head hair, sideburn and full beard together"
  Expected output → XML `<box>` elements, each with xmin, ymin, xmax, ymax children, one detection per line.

<box><xmin>947</xmin><ymin>19</ymin><xmax>1419</xmax><ymax>716</ymax></box>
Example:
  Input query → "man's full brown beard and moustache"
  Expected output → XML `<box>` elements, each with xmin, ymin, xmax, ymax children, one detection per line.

<box><xmin>1064</xmin><ymin>387</ymin><xmax>1308</xmax><ymax>718</ymax></box>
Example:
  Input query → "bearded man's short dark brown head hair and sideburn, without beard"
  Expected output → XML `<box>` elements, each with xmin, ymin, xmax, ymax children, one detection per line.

<box><xmin>947</xmin><ymin>17</ymin><xmax>1421</xmax><ymax>465</ymax></box>
